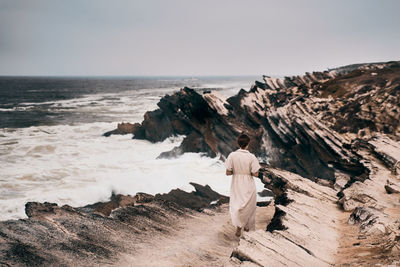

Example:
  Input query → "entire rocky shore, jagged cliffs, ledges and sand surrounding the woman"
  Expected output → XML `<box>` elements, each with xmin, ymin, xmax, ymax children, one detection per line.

<box><xmin>0</xmin><ymin>62</ymin><xmax>400</xmax><ymax>266</ymax></box>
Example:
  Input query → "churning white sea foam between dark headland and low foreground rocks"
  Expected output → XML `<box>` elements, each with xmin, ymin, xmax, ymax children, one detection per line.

<box><xmin>0</xmin><ymin>123</ymin><xmax>268</xmax><ymax>220</ymax></box>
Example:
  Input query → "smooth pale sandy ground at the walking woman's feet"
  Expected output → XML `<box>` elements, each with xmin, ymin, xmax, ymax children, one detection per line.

<box><xmin>118</xmin><ymin>203</ymin><xmax>274</xmax><ymax>266</ymax></box>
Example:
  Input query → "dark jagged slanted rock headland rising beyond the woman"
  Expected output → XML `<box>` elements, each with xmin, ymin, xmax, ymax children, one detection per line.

<box><xmin>104</xmin><ymin>62</ymin><xmax>400</xmax><ymax>181</ymax></box>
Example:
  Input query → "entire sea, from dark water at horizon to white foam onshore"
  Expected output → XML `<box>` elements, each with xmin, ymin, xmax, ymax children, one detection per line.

<box><xmin>0</xmin><ymin>76</ymin><xmax>263</xmax><ymax>220</ymax></box>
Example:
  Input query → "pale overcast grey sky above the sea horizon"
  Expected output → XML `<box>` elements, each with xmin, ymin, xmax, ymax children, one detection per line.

<box><xmin>0</xmin><ymin>0</ymin><xmax>400</xmax><ymax>75</ymax></box>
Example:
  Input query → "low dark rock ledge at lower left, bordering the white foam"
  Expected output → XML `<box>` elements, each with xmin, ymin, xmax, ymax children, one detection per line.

<box><xmin>0</xmin><ymin>183</ymin><xmax>227</xmax><ymax>266</ymax></box>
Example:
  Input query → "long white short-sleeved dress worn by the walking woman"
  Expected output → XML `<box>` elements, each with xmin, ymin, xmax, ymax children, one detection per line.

<box><xmin>225</xmin><ymin>149</ymin><xmax>260</xmax><ymax>230</ymax></box>
